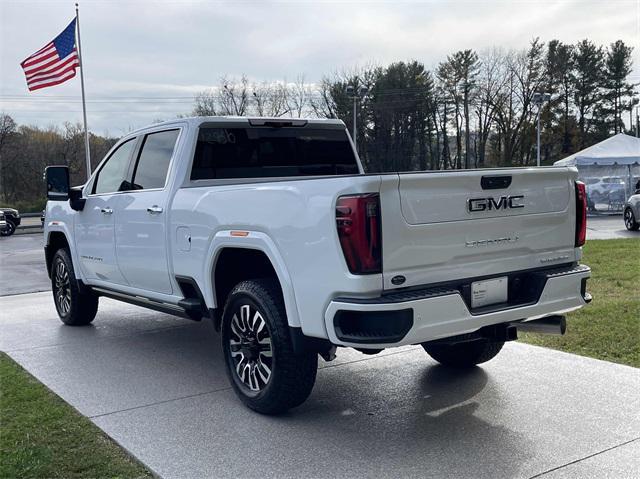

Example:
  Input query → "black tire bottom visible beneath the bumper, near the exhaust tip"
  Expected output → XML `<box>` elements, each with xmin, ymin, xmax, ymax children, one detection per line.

<box><xmin>422</xmin><ymin>339</ymin><xmax>504</xmax><ymax>368</ymax></box>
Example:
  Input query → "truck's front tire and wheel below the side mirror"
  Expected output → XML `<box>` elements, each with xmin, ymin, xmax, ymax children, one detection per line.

<box><xmin>51</xmin><ymin>248</ymin><xmax>98</xmax><ymax>326</ymax></box>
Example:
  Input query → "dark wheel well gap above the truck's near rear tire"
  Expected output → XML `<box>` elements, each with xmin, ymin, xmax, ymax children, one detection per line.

<box><xmin>213</xmin><ymin>248</ymin><xmax>281</xmax><ymax>313</ymax></box>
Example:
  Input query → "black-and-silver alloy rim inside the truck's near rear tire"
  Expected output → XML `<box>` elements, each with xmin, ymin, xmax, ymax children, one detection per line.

<box><xmin>229</xmin><ymin>304</ymin><xmax>273</xmax><ymax>392</ymax></box>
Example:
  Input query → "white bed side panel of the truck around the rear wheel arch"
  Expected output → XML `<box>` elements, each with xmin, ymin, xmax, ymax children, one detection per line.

<box><xmin>170</xmin><ymin>175</ymin><xmax>382</xmax><ymax>337</ymax></box>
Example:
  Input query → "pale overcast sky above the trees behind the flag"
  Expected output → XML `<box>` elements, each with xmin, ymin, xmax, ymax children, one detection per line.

<box><xmin>0</xmin><ymin>0</ymin><xmax>640</xmax><ymax>136</ymax></box>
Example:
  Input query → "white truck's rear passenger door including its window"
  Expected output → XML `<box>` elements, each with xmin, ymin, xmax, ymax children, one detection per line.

<box><xmin>115</xmin><ymin>128</ymin><xmax>180</xmax><ymax>294</ymax></box>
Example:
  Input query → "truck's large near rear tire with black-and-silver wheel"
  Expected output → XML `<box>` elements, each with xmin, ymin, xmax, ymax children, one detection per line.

<box><xmin>221</xmin><ymin>279</ymin><xmax>318</xmax><ymax>414</ymax></box>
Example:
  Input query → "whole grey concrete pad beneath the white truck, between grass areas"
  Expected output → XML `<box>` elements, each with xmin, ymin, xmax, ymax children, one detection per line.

<box><xmin>0</xmin><ymin>294</ymin><xmax>640</xmax><ymax>478</ymax></box>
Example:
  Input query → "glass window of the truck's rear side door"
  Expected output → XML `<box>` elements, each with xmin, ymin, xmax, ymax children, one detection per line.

<box><xmin>132</xmin><ymin>130</ymin><xmax>180</xmax><ymax>190</ymax></box>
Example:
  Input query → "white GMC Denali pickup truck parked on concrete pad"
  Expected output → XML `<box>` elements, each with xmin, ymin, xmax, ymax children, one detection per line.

<box><xmin>44</xmin><ymin>117</ymin><xmax>591</xmax><ymax>414</ymax></box>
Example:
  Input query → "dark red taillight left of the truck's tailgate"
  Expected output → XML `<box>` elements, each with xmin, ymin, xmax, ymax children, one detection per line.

<box><xmin>336</xmin><ymin>193</ymin><xmax>382</xmax><ymax>274</ymax></box>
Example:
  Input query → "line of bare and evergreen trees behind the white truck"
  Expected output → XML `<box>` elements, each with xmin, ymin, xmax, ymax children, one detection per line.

<box><xmin>0</xmin><ymin>39</ymin><xmax>638</xmax><ymax>209</ymax></box>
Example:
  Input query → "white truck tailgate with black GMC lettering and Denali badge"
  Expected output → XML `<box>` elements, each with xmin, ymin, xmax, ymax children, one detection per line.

<box><xmin>381</xmin><ymin>168</ymin><xmax>577</xmax><ymax>289</ymax></box>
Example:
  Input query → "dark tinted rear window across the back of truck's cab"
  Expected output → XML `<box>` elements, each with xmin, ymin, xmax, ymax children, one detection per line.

<box><xmin>191</xmin><ymin>127</ymin><xmax>358</xmax><ymax>180</ymax></box>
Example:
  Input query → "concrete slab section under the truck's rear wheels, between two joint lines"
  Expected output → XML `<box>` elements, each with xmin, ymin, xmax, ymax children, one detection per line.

<box><xmin>95</xmin><ymin>345</ymin><xmax>640</xmax><ymax>478</ymax></box>
